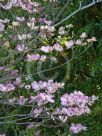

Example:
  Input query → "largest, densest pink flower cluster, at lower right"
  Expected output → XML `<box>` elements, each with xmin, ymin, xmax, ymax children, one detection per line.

<box><xmin>55</xmin><ymin>91</ymin><xmax>98</xmax><ymax>118</ymax></box>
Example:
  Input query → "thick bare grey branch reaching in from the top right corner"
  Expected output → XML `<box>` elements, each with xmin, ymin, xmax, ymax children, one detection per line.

<box><xmin>54</xmin><ymin>0</ymin><xmax>102</xmax><ymax>27</ymax></box>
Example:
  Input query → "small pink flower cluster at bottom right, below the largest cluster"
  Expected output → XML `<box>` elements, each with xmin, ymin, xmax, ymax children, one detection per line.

<box><xmin>69</xmin><ymin>123</ymin><xmax>87</xmax><ymax>134</ymax></box>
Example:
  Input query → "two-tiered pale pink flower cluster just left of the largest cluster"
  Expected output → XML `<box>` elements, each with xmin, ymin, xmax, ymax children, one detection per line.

<box><xmin>30</xmin><ymin>80</ymin><xmax>64</xmax><ymax>106</ymax></box>
